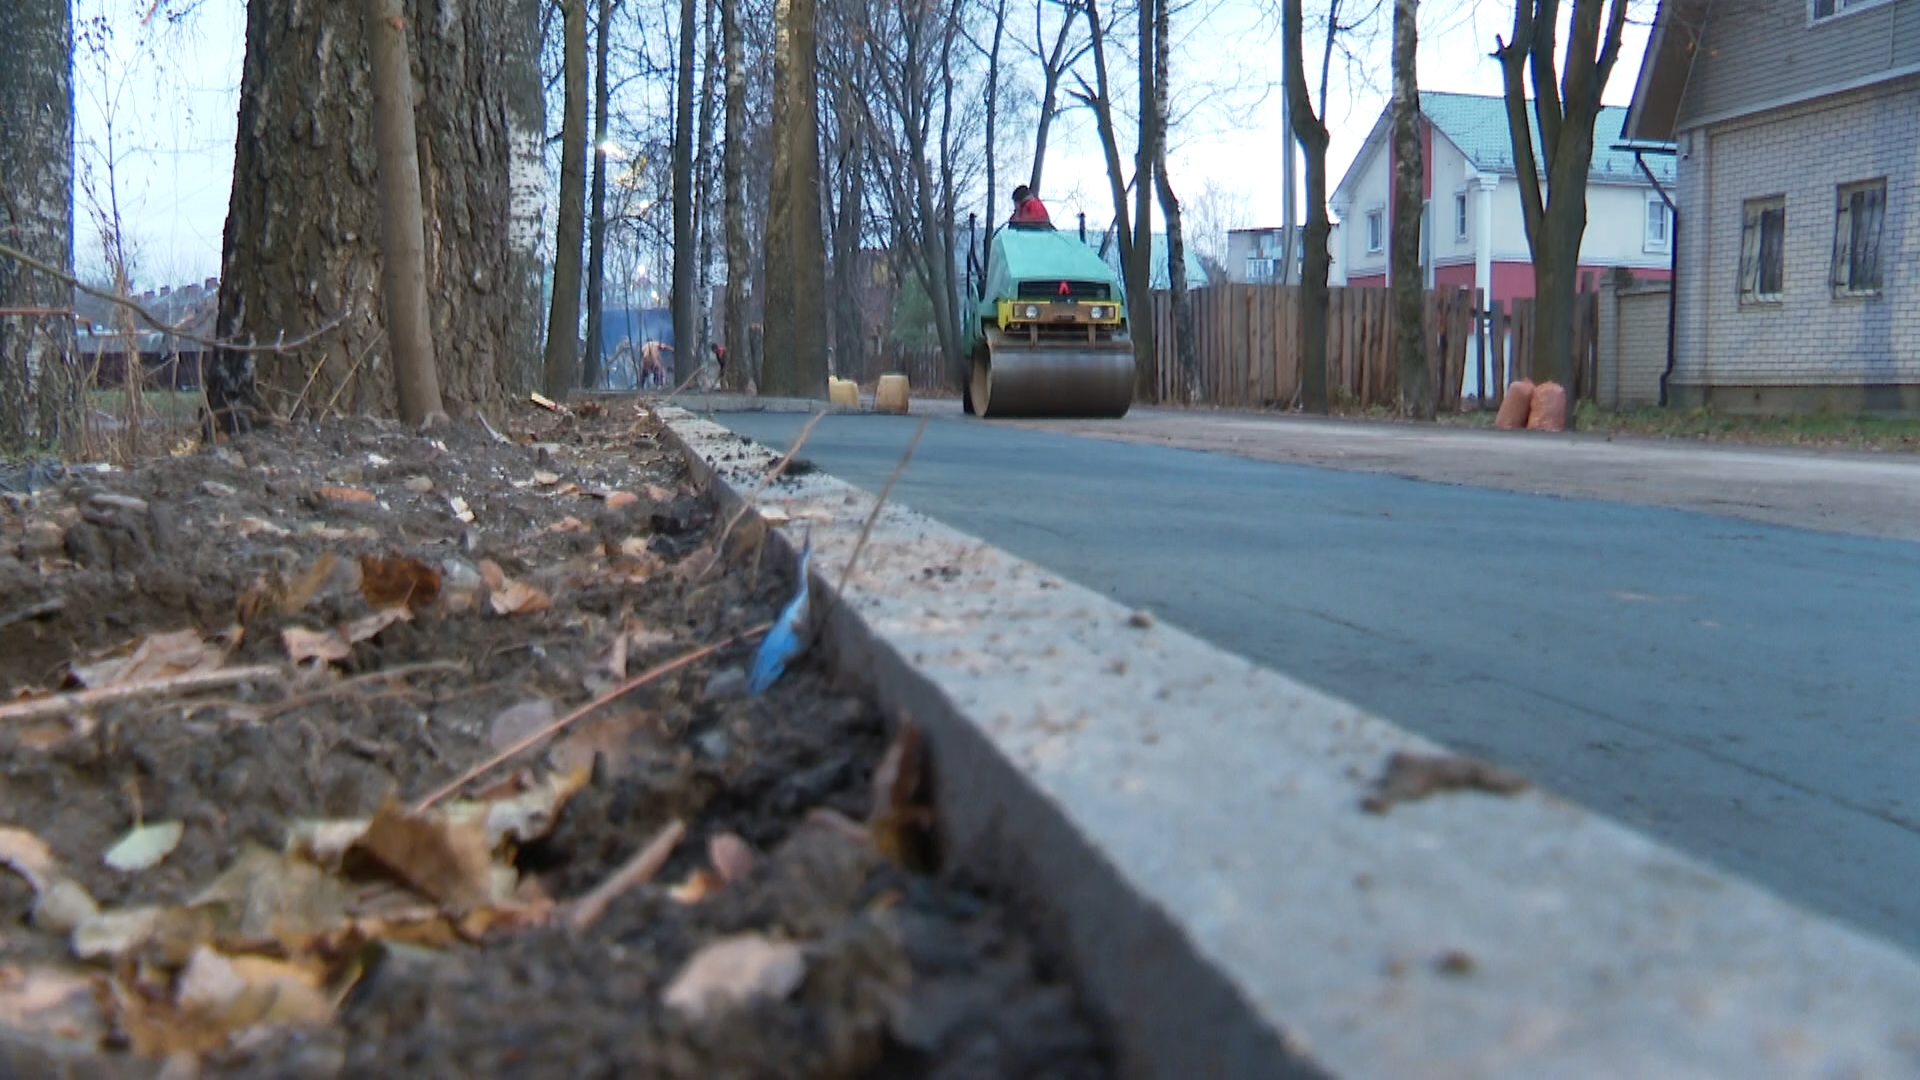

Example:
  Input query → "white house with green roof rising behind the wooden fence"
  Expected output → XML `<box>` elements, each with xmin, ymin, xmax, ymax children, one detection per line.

<box><xmin>1329</xmin><ymin>92</ymin><xmax>1674</xmax><ymax>302</ymax></box>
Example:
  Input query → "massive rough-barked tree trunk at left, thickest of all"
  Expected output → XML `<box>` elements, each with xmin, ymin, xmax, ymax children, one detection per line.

<box><xmin>207</xmin><ymin>0</ymin><xmax>545</xmax><ymax>429</ymax></box>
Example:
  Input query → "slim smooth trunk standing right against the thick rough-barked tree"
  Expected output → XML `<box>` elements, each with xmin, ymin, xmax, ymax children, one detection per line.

<box><xmin>361</xmin><ymin>0</ymin><xmax>445</xmax><ymax>427</ymax></box>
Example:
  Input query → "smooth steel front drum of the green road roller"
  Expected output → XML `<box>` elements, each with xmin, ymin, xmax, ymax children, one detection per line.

<box><xmin>972</xmin><ymin>340</ymin><xmax>1133</xmax><ymax>419</ymax></box>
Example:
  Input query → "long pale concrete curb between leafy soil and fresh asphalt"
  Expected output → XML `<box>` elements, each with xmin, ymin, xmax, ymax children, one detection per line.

<box><xmin>662</xmin><ymin>399</ymin><xmax>1920</xmax><ymax>1078</ymax></box>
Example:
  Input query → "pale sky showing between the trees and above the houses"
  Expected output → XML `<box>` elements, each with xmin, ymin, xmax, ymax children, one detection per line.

<box><xmin>75</xmin><ymin>0</ymin><xmax>1645</xmax><ymax>288</ymax></box>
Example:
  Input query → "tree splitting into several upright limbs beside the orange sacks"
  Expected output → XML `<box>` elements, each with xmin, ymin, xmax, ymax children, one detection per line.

<box><xmin>1494</xmin><ymin>0</ymin><xmax>1626</xmax><ymax>419</ymax></box>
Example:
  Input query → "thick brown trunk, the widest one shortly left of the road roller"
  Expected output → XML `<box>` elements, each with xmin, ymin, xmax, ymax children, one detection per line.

<box><xmin>760</xmin><ymin>0</ymin><xmax>828</xmax><ymax>398</ymax></box>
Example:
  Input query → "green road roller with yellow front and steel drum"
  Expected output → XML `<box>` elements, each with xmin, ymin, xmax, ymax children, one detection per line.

<box><xmin>960</xmin><ymin>225</ymin><xmax>1133</xmax><ymax>417</ymax></box>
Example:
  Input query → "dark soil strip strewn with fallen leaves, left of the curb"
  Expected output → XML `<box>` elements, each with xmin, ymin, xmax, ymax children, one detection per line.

<box><xmin>0</xmin><ymin>402</ymin><xmax>1112</xmax><ymax>1078</ymax></box>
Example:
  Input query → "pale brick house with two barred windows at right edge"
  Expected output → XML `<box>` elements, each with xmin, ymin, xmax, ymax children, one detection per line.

<box><xmin>1626</xmin><ymin>0</ymin><xmax>1920</xmax><ymax>413</ymax></box>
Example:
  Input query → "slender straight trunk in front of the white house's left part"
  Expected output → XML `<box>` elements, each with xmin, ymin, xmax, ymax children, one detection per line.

<box><xmin>1388</xmin><ymin>0</ymin><xmax>1434</xmax><ymax>419</ymax></box>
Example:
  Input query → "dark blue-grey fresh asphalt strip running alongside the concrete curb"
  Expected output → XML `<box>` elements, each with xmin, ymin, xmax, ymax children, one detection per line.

<box><xmin>716</xmin><ymin>413</ymin><xmax>1920</xmax><ymax>953</ymax></box>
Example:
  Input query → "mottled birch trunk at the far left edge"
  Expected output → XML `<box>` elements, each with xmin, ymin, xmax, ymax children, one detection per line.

<box><xmin>0</xmin><ymin>0</ymin><xmax>84</xmax><ymax>455</ymax></box>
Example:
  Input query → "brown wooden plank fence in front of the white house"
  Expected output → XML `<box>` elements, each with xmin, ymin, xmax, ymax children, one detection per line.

<box><xmin>1154</xmin><ymin>284</ymin><xmax>1599</xmax><ymax>411</ymax></box>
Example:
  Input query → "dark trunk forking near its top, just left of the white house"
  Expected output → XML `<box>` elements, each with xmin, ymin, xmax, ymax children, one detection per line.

<box><xmin>1281</xmin><ymin>0</ymin><xmax>1340</xmax><ymax>415</ymax></box>
